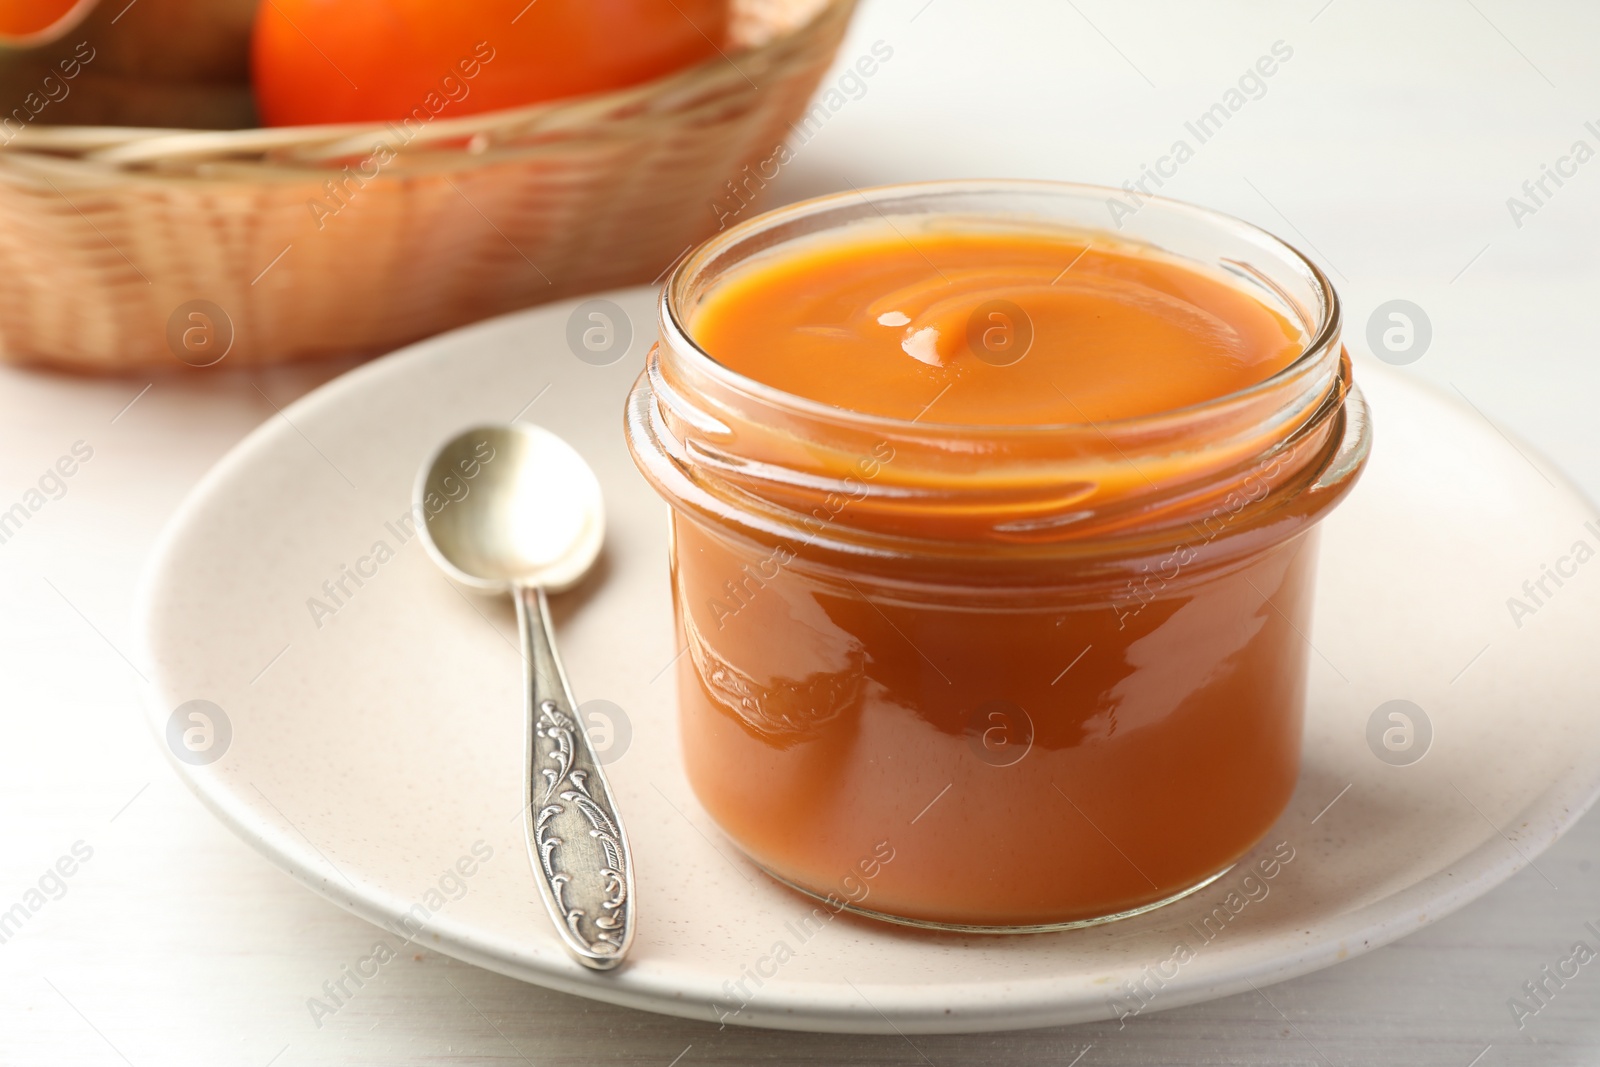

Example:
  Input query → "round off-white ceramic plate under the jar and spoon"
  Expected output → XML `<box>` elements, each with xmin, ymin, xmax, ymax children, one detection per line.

<box><xmin>141</xmin><ymin>290</ymin><xmax>1600</xmax><ymax>1032</ymax></box>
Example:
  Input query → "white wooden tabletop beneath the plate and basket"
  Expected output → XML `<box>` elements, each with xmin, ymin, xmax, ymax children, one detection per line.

<box><xmin>0</xmin><ymin>0</ymin><xmax>1600</xmax><ymax>1067</ymax></box>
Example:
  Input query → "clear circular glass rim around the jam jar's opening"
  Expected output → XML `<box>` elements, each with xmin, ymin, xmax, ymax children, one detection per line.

<box><xmin>659</xmin><ymin>178</ymin><xmax>1342</xmax><ymax>437</ymax></box>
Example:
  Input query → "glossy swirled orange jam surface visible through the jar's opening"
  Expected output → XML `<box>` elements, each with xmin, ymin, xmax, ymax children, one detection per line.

<box><xmin>690</xmin><ymin>232</ymin><xmax>1302</xmax><ymax>426</ymax></box>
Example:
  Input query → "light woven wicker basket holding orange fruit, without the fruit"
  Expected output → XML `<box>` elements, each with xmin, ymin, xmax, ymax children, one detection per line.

<box><xmin>0</xmin><ymin>0</ymin><xmax>854</xmax><ymax>373</ymax></box>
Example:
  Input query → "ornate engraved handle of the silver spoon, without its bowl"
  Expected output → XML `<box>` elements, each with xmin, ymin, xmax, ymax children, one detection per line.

<box><xmin>515</xmin><ymin>585</ymin><xmax>634</xmax><ymax>971</ymax></box>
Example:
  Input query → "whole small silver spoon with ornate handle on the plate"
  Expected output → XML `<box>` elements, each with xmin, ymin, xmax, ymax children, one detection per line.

<box><xmin>414</xmin><ymin>424</ymin><xmax>634</xmax><ymax>971</ymax></box>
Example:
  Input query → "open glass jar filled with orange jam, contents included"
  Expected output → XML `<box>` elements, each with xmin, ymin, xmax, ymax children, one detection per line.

<box><xmin>627</xmin><ymin>182</ymin><xmax>1368</xmax><ymax>931</ymax></box>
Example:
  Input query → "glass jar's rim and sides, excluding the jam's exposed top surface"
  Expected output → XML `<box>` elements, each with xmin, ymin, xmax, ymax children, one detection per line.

<box><xmin>627</xmin><ymin>181</ymin><xmax>1370</xmax><ymax>931</ymax></box>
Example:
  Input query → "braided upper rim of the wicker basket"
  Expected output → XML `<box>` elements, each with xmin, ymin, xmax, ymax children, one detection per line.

<box><xmin>0</xmin><ymin>0</ymin><xmax>856</xmax><ymax>173</ymax></box>
